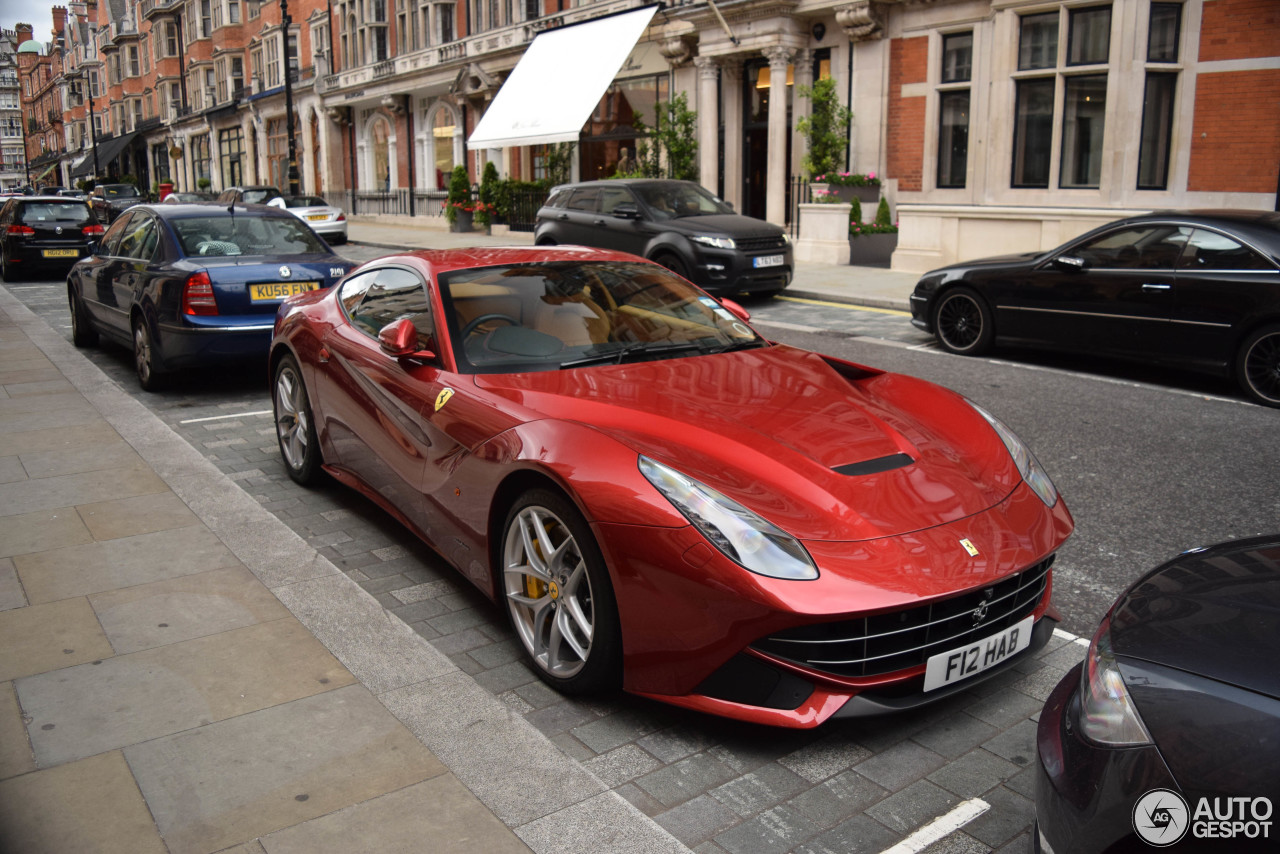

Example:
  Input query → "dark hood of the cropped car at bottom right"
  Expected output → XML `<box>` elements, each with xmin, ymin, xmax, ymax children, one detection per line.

<box><xmin>1111</xmin><ymin>535</ymin><xmax>1280</xmax><ymax>699</ymax></box>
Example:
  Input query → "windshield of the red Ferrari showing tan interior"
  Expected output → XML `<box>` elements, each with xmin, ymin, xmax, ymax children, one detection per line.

<box><xmin>439</xmin><ymin>261</ymin><xmax>767</xmax><ymax>374</ymax></box>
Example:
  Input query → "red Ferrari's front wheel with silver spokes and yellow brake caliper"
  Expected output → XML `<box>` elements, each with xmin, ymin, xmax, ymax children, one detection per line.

<box><xmin>498</xmin><ymin>489</ymin><xmax>622</xmax><ymax>694</ymax></box>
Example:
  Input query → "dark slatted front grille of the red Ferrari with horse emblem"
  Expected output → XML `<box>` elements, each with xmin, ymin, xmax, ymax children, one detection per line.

<box><xmin>751</xmin><ymin>556</ymin><xmax>1053</xmax><ymax>676</ymax></box>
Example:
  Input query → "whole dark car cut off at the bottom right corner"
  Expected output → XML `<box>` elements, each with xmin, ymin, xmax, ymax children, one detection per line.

<box><xmin>1036</xmin><ymin>535</ymin><xmax>1280</xmax><ymax>854</ymax></box>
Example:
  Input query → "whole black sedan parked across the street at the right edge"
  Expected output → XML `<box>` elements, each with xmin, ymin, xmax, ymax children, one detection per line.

<box><xmin>911</xmin><ymin>210</ymin><xmax>1280</xmax><ymax>406</ymax></box>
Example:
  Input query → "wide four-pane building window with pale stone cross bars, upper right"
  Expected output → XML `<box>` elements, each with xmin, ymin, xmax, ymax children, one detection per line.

<box><xmin>1011</xmin><ymin>6</ymin><xmax>1111</xmax><ymax>188</ymax></box>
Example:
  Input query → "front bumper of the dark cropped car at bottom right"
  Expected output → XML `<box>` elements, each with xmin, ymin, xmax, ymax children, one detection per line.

<box><xmin>1036</xmin><ymin>665</ymin><xmax>1172</xmax><ymax>854</ymax></box>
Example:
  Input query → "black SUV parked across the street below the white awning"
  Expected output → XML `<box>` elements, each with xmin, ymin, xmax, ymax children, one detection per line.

<box><xmin>534</xmin><ymin>179</ymin><xmax>792</xmax><ymax>294</ymax></box>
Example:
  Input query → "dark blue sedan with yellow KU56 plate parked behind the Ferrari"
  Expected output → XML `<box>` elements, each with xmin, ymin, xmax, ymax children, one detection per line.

<box><xmin>67</xmin><ymin>204</ymin><xmax>355</xmax><ymax>391</ymax></box>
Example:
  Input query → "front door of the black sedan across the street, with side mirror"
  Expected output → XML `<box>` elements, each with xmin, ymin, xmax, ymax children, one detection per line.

<box><xmin>995</xmin><ymin>223</ymin><xmax>1185</xmax><ymax>355</ymax></box>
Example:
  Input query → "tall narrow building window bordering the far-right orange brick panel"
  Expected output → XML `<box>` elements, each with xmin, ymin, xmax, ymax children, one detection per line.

<box><xmin>1138</xmin><ymin>3</ymin><xmax>1183</xmax><ymax>189</ymax></box>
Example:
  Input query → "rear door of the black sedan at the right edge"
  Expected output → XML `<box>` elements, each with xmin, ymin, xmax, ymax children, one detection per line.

<box><xmin>1162</xmin><ymin>228</ymin><xmax>1280</xmax><ymax>370</ymax></box>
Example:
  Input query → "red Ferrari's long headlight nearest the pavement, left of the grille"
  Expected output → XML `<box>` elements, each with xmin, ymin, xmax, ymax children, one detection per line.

<box><xmin>640</xmin><ymin>457</ymin><xmax>818</xmax><ymax>581</ymax></box>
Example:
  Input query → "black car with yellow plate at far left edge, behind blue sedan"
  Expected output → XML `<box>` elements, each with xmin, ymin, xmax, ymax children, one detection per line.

<box><xmin>0</xmin><ymin>196</ymin><xmax>102</xmax><ymax>282</ymax></box>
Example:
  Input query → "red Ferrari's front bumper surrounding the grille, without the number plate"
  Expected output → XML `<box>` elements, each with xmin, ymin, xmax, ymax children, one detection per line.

<box><xmin>596</xmin><ymin>484</ymin><xmax>1073</xmax><ymax>727</ymax></box>
